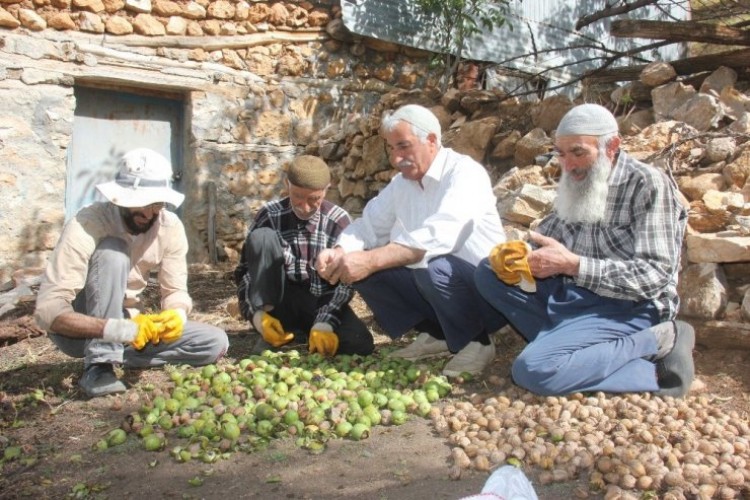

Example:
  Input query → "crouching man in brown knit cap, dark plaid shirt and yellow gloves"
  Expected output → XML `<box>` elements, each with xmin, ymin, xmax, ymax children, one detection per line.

<box><xmin>234</xmin><ymin>155</ymin><xmax>374</xmax><ymax>356</ymax></box>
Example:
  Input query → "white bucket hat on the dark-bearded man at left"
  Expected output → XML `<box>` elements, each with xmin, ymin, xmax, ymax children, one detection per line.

<box><xmin>96</xmin><ymin>148</ymin><xmax>185</xmax><ymax>208</ymax></box>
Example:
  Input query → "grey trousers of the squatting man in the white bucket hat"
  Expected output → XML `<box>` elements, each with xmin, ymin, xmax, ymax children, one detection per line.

<box><xmin>49</xmin><ymin>237</ymin><xmax>229</xmax><ymax>368</ymax></box>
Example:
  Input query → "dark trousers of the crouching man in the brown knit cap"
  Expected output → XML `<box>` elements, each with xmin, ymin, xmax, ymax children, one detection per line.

<box><xmin>244</xmin><ymin>228</ymin><xmax>374</xmax><ymax>355</ymax></box>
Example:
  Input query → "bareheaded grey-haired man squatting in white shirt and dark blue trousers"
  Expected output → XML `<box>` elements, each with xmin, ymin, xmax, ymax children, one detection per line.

<box><xmin>317</xmin><ymin>104</ymin><xmax>505</xmax><ymax>376</ymax></box>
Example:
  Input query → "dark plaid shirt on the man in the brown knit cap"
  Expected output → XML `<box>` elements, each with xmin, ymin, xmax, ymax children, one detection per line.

<box><xmin>234</xmin><ymin>197</ymin><xmax>354</xmax><ymax>330</ymax></box>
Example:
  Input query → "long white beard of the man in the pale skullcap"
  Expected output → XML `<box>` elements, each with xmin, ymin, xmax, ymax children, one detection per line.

<box><xmin>555</xmin><ymin>150</ymin><xmax>612</xmax><ymax>224</ymax></box>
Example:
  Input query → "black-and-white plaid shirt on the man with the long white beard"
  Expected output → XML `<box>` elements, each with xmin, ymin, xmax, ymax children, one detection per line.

<box><xmin>536</xmin><ymin>151</ymin><xmax>687</xmax><ymax>321</ymax></box>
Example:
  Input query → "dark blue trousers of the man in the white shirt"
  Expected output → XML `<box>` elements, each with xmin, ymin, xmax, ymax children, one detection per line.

<box><xmin>354</xmin><ymin>255</ymin><xmax>507</xmax><ymax>353</ymax></box>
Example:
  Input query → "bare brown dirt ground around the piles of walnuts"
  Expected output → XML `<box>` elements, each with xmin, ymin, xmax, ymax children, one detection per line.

<box><xmin>0</xmin><ymin>268</ymin><xmax>750</xmax><ymax>500</ymax></box>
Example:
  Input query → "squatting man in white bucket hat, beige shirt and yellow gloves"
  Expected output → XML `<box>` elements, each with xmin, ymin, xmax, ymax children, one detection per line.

<box><xmin>35</xmin><ymin>148</ymin><xmax>228</xmax><ymax>397</ymax></box>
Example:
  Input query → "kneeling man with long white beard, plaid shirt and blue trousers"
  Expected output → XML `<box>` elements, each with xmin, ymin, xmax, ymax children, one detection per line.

<box><xmin>475</xmin><ymin>104</ymin><xmax>695</xmax><ymax>397</ymax></box>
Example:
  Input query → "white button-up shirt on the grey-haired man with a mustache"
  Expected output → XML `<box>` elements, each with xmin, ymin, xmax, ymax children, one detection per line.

<box><xmin>337</xmin><ymin>147</ymin><xmax>505</xmax><ymax>268</ymax></box>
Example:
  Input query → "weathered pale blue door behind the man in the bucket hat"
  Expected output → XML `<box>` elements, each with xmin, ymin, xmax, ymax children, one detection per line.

<box><xmin>65</xmin><ymin>87</ymin><xmax>184</xmax><ymax>220</ymax></box>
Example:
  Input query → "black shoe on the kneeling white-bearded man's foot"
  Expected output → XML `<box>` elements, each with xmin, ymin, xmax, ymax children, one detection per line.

<box><xmin>655</xmin><ymin>321</ymin><xmax>695</xmax><ymax>398</ymax></box>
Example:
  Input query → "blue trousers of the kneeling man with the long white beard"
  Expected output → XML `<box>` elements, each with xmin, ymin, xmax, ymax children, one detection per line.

<box><xmin>475</xmin><ymin>259</ymin><xmax>659</xmax><ymax>395</ymax></box>
